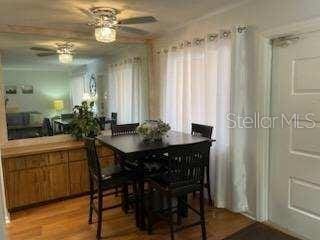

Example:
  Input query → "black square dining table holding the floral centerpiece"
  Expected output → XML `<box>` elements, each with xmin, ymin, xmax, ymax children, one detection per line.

<box><xmin>97</xmin><ymin>131</ymin><xmax>213</xmax><ymax>229</ymax></box>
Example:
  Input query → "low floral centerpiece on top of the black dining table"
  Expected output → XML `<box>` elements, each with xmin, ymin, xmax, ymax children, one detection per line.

<box><xmin>137</xmin><ymin>120</ymin><xmax>170</xmax><ymax>142</ymax></box>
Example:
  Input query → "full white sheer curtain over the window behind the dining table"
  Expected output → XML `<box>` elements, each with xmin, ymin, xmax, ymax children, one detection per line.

<box><xmin>156</xmin><ymin>28</ymin><xmax>248</xmax><ymax>212</ymax></box>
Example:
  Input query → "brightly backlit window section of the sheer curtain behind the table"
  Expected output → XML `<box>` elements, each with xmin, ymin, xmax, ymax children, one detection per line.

<box><xmin>158</xmin><ymin>39</ymin><xmax>220</xmax><ymax>133</ymax></box>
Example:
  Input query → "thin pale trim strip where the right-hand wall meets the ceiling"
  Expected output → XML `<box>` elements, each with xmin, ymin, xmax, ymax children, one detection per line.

<box><xmin>166</xmin><ymin>0</ymin><xmax>252</xmax><ymax>33</ymax></box>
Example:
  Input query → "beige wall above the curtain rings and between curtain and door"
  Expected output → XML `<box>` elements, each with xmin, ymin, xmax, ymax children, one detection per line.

<box><xmin>150</xmin><ymin>0</ymin><xmax>320</xmax><ymax>217</ymax></box>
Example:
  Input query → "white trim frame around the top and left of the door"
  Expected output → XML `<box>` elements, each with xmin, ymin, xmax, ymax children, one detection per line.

<box><xmin>256</xmin><ymin>18</ymin><xmax>320</xmax><ymax>222</ymax></box>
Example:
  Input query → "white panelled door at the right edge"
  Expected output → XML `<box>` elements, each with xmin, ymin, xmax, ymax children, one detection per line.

<box><xmin>269</xmin><ymin>32</ymin><xmax>320</xmax><ymax>240</ymax></box>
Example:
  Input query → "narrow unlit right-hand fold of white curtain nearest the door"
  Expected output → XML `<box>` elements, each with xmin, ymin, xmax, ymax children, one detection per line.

<box><xmin>230</xmin><ymin>26</ymin><xmax>253</xmax><ymax>212</ymax></box>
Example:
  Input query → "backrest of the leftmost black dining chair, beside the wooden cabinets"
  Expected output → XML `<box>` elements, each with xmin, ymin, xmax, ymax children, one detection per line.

<box><xmin>84</xmin><ymin>137</ymin><xmax>101</xmax><ymax>180</ymax></box>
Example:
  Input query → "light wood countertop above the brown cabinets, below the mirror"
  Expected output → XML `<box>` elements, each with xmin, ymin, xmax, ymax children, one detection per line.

<box><xmin>1</xmin><ymin>141</ymin><xmax>84</xmax><ymax>158</ymax></box>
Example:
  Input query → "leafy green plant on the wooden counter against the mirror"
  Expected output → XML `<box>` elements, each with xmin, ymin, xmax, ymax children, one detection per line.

<box><xmin>71</xmin><ymin>101</ymin><xmax>100</xmax><ymax>140</ymax></box>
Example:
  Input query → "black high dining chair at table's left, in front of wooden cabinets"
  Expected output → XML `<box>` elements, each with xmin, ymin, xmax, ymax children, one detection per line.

<box><xmin>84</xmin><ymin>137</ymin><xmax>136</xmax><ymax>239</ymax></box>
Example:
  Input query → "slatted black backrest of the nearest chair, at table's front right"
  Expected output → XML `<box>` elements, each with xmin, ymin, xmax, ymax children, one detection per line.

<box><xmin>168</xmin><ymin>141</ymin><xmax>210</xmax><ymax>186</ymax></box>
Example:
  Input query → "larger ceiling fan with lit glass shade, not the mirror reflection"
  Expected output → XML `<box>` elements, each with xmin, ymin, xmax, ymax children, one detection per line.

<box><xmin>80</xmin><ymin>7</ymin><xmax>157</xmax><ymax>42</ymax></box>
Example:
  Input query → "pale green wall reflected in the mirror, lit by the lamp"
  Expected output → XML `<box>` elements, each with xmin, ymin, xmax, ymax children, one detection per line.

<box><xmin>4</xmin><ymin>68</ymin><xmax>71</xmax><ymax>116</ymax></box>
